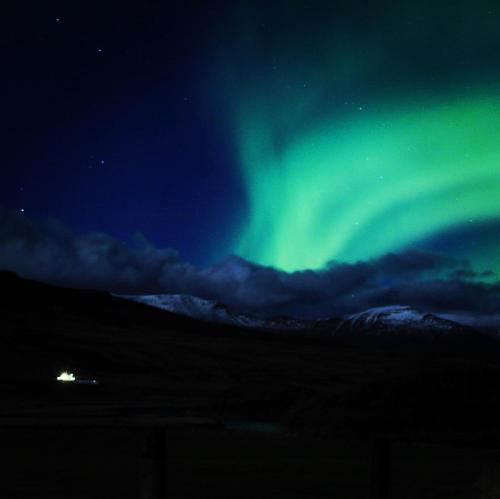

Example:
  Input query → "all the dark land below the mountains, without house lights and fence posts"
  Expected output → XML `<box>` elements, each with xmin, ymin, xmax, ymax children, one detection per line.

<box><xmin>0</xmin><ymin>273</ymin><xmax>500</xmax><ymax>499</ymax></box>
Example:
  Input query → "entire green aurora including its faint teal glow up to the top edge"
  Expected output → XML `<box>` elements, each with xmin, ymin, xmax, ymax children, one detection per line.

<box><xmin>211</xmin><ymin>2</ymin><xmax>500</xmax><ymax>272</ymax></box>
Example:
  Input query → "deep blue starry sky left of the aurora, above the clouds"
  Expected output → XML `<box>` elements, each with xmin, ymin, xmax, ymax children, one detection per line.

<box><xmin>0</xmin><ymin>2</ymin><xmax>242</xmax><ymax>263</ymax></box>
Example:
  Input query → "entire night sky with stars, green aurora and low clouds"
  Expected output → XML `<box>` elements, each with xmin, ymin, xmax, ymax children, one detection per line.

<box><xmin>0</xmin><ymin>0</ymin><xmax>500</xmax><ymax>314</ymax></box>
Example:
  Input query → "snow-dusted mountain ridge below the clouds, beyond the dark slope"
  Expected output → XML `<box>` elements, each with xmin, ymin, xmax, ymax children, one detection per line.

<box><xmin>122</xmin><ymin>294</ymin><xmax>492</xmax><ymax>348</ymax></box>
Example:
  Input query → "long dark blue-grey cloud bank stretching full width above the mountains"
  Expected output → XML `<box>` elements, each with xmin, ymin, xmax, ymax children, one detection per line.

<box><xmin>0</xmin><ymin>210</ymin><xmax>500</xmax><ymax>317</ymax></box>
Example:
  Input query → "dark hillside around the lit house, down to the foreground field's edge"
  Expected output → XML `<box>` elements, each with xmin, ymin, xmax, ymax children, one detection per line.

<box><xmin>0</xmin><ymin>272</ymin><xmax>500</xmax><ymax>442</ymax></box>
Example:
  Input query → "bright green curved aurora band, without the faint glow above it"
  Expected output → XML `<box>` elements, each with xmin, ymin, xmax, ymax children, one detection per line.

<box><xmin>235</xmin><ymin>93</ymin><xmax>500</xmax><ymax>271</ymax></box>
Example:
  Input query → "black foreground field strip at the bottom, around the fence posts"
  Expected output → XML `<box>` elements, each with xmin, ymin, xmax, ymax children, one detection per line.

<box><xmin>0</xmin><ymin>428</ymin><xmax>500</xmax><ymax>499</ymax></box>
